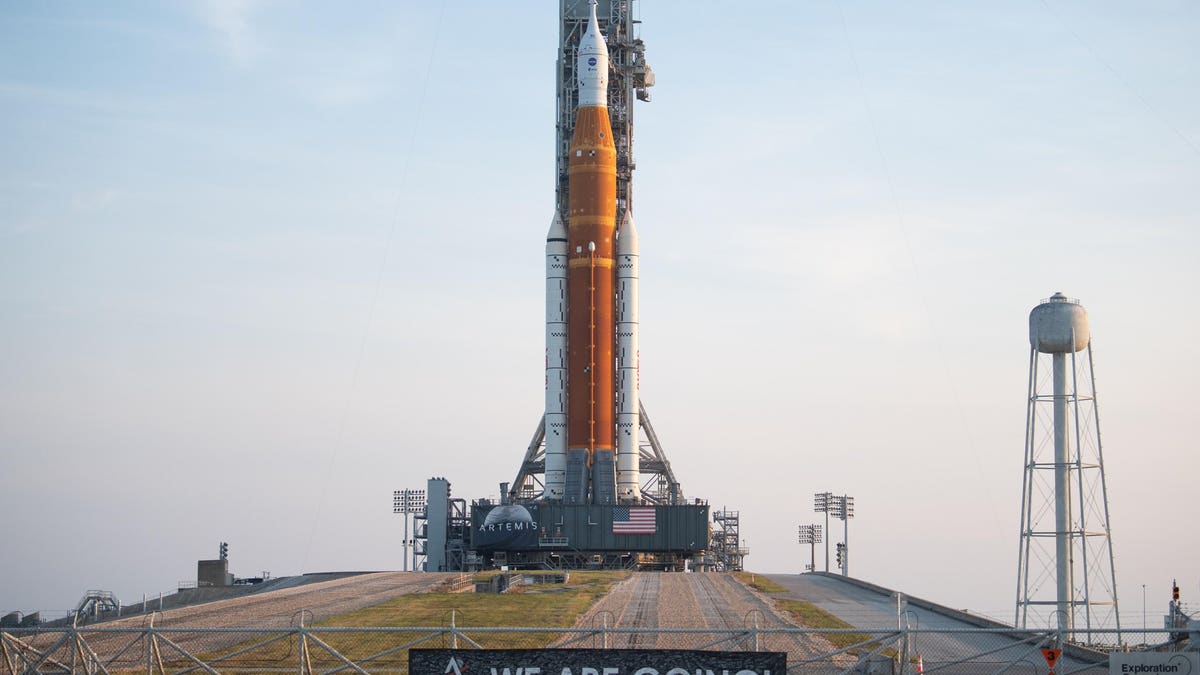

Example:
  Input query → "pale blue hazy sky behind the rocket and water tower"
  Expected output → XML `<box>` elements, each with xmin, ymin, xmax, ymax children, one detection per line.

<box><xmin>0</xmin><ymin>0</ymin><xmax>1200</xmax><ymax>626</ymax></box>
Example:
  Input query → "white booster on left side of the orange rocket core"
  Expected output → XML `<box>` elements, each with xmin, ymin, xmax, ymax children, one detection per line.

<box><xmin>544</xmin><ymin>213</ymin><xmax>566</xmax><ymax>500</ymax></box>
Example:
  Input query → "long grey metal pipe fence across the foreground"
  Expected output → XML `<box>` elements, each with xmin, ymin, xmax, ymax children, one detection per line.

<box><xmin>0</xmin><ymin>621</ymin><xmax>1170</xmax><ymax>675</ymax></box>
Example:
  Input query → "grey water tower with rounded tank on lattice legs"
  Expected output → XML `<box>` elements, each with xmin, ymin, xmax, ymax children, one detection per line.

<box><xmin>1014</xmin><ymin>293</ymin><xmax>1121</xmax><ymax>643</ymax></box>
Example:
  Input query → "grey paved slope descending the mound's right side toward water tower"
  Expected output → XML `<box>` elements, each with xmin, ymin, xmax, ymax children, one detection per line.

<box><xmin>764</xmin><ymin>573</ymin><xmax>1108</xmax><ymax>675</ymax></box>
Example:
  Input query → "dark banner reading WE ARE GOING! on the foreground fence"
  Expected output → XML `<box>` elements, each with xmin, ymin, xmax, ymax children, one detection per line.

<box><xmin>408</xmin><ymin>650</ymin><xmax>787</xmax><ymax>675</ymax></box>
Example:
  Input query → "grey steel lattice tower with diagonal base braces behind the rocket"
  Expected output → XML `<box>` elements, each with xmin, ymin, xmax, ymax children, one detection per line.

<box><xmin>505</xmin><ymin>0</ymin><xmax>684</xmax><ymax>504</ymax></box>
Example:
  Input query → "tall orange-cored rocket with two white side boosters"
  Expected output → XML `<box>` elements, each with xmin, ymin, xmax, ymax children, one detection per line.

<box><xmin>544</xmin><ymin>0</ymin><xmax>641</xmax><ymax>504</ymax></box>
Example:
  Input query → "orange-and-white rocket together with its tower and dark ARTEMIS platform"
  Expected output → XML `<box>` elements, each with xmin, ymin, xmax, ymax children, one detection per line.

<box><xmin>472</xmin><ymin>0</ymin><xmax>713</xmax><ymax>569</ymax></box>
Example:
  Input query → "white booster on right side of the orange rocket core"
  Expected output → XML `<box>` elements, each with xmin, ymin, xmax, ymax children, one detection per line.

<box><xmin>617</xmin><ymin>211</ymin><xmax>642</xmax><ymax>501</ymax></box>
